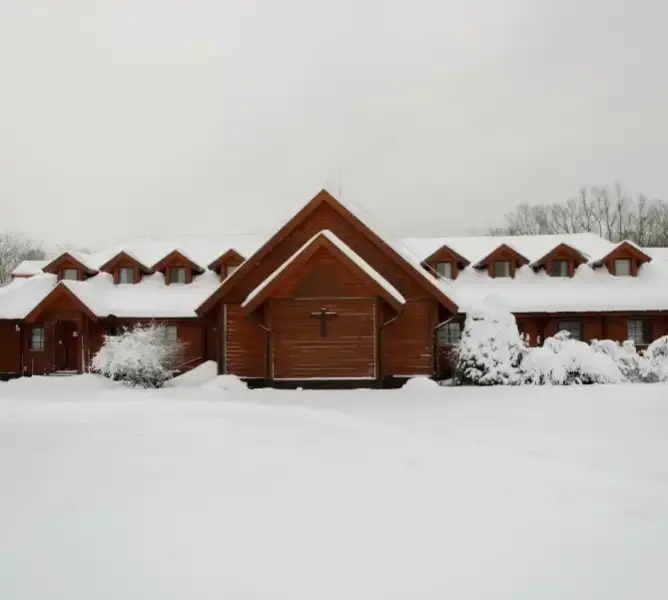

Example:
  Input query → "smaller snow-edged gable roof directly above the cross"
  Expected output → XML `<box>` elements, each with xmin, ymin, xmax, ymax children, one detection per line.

<box><xmin>241</xmin><ymin>229</ymin><xmax>406</xmax><ymax>312</ymax></box>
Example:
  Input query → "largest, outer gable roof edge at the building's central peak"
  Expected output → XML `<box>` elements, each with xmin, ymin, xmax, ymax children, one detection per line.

<box><xmin>197</xmin><ymin>189</ymin><xmax>458</xmax><ymax>316</ymax></box>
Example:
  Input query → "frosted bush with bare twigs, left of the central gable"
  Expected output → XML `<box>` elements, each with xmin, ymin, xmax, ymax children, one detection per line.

<box><xmin>91</xmin><ymin>324</ymin><xmax>183</xmax><ymax>388</ymax></box>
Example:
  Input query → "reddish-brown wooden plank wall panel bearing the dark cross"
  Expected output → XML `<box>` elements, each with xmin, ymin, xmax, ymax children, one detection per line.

<box><xmin>270</xmin><ymin>298</ymin><xmax>376</xmax><ymax>380</ymax></box>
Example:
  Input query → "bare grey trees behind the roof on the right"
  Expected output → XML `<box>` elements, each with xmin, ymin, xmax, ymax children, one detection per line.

<box><xmin>489</xmin><ymin>184</ymin><xmax>668</xmax><ymax>247</ymax></box>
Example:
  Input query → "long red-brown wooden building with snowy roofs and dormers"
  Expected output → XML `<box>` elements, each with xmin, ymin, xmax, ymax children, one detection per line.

<box><xmin>0</xmin><ymin>191</ymin><xmax>668</xmax><ymax>385</ymax></box>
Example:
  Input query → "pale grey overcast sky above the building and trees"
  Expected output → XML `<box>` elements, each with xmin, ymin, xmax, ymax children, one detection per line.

<box><xmin>0</xmin><ymin>0</ymin><xmax>668</xmax><ymax>246</ymax></box>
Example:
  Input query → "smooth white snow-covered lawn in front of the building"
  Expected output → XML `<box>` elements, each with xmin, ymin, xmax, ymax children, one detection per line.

<box><xmin>0</xmin><ymin>376</ymin><xmax>668</xmax><ymax>600</ymax></box>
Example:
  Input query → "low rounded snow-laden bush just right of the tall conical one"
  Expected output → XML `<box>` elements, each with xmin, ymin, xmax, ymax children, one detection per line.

<box><xmin>522</xmin><ymin>331</ymin><xmax>625</xmax><ymax>385</ymax></box>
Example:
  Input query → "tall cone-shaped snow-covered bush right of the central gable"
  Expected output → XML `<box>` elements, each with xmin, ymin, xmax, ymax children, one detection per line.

<box><xmin>455</xmin><ymin>297</ymin><xmax>526</xmax><ymax>385</ymax></box>
